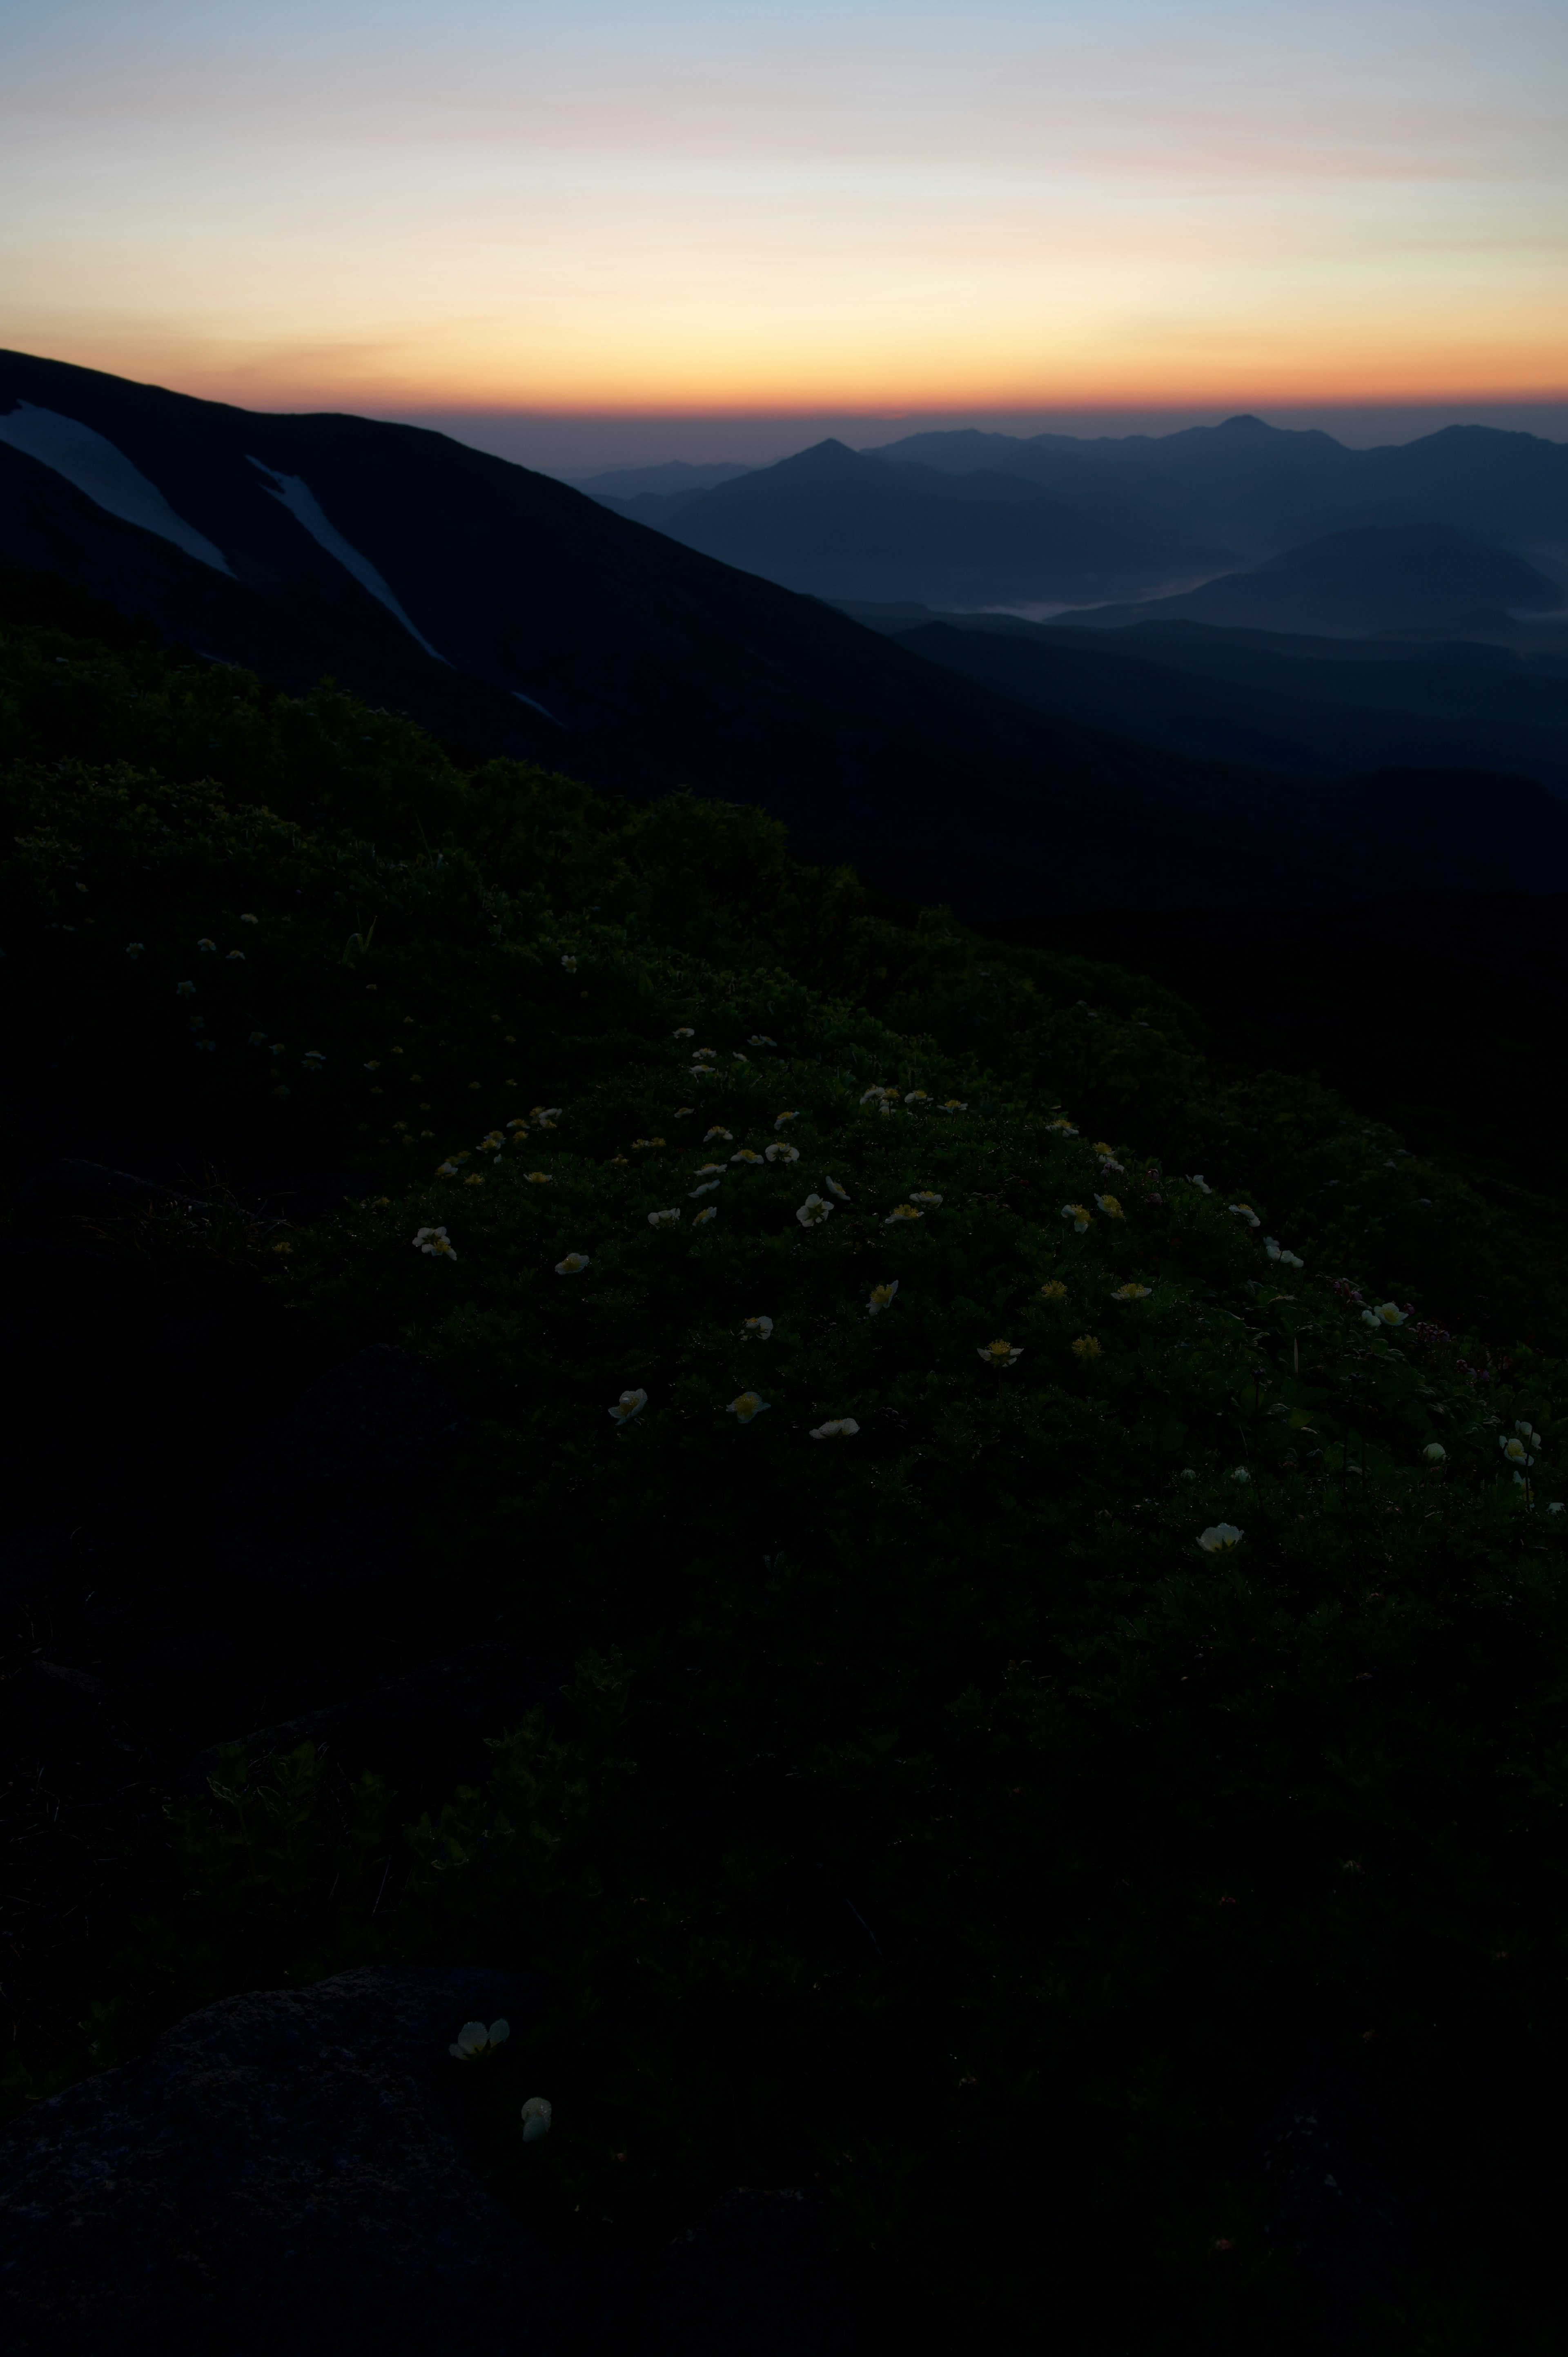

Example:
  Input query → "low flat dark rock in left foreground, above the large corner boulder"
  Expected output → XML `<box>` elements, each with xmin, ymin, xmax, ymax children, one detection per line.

<box><xmin>179</xmin><ymin>1643</ymin><xmax>561</xmax><ymax>1808</ymax></box>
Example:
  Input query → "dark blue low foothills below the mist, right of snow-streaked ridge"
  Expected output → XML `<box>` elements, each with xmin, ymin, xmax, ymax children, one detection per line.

<box><xmin>858</xmin><ymin>611</ymin><xmax>1568</xmax><ymax>797</ymax></box>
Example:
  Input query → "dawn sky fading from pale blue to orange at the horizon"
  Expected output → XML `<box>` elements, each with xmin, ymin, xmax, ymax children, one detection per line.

<box><xmin>0</xmin><ymin>0</ymin><xmax>1568</xmax><ymax>464</ymax></box>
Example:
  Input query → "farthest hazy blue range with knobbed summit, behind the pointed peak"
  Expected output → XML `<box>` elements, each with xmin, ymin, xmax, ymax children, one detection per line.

<box><xmin>868</xmin><ymin>417</ymin><xmax>1568</xmax><ymax>554</ymax></box>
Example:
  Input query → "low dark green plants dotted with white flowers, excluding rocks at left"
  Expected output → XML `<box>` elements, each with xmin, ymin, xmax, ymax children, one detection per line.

<box><xmin>0</xmin><ymin>582</ymin><xmax>1568</xmax><ymax>2352</ymax></box>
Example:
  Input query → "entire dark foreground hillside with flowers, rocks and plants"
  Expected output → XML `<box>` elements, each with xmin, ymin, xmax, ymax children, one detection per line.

<box><xmin>0</xmin><ymin>580</ymin><xmax>1568</xmax><ymax>2357</ymax></box>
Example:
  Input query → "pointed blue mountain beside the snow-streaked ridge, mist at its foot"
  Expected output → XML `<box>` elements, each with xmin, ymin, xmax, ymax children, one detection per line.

<box><xmin>587</xmin><ymin>441</ymin><xmax>1228</xmax><ymax>606</ymax></box>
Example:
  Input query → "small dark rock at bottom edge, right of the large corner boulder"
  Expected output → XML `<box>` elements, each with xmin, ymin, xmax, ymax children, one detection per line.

<box><xmin>648</xmin><ymin>2190</ymin><xmax>861</xmax><ymax>2357</ymax></box>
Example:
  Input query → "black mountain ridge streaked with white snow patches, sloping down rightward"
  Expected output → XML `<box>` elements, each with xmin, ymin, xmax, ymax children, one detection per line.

<box><xmin>0</xmin><ymin>356</ymin><xmax>1568</xmax><ymax>914</ymax></box>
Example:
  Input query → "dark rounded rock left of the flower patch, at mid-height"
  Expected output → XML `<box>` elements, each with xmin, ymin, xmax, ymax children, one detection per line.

<box><xmin>214</xmin><ymin>1343</ymin><xmax>465</xmax><ymax>1603</ymax></box>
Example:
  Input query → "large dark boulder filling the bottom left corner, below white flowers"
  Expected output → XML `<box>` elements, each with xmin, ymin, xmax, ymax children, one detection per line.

<box><xmin>0</xmin><ymin>1968</ymin><xmax>559</xmax><ymax>2357</ymax></box>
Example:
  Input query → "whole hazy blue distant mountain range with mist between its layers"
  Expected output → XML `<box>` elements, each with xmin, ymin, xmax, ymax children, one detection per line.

<box><xmin>582</xmin><ymin>417</ymin><xmax>1568</xmax><ymax>634</ymax></box>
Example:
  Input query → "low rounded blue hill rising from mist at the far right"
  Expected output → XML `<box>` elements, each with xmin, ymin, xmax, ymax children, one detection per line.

<box><xmin>1051</xmin><ymin>523</ymin><xmax>1568</xmax><ymax>639</ymax></box>
